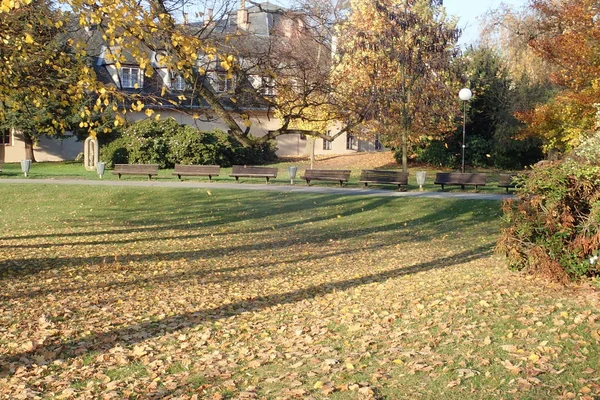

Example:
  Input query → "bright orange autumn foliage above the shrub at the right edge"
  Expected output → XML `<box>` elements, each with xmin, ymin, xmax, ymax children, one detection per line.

<box><xmin>519</xmin><ymin>0</ymin><xmax>600</xmax><ymax>152</ymax></box>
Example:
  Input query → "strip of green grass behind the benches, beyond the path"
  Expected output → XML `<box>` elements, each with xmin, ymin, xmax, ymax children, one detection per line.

<box><xmin>0</xmin><ymin>160</ymin><xmax>516</xmax><ymax>193</ymax></box>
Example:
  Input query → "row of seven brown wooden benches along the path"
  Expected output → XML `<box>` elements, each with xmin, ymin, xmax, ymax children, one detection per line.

<box><xmin>113</xmin><ymin>164</ymin><xmax>515</xmax><ymax>193</ymax></box>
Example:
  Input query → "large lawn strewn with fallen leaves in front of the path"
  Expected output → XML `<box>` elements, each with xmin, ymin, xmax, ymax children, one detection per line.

<box><xmin>0</xmin><ymin>183</ymin><xmax>600</xmax><ymax>399</ymax></box>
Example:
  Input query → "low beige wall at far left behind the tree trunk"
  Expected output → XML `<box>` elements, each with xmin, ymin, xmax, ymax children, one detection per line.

<box><xmin>0</xmin><ymin>131</ymin><xmax>83</xmax><ymax>163</ymax></box>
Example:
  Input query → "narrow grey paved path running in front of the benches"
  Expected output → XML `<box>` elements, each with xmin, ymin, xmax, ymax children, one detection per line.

<box><xmin>0</xmin><ymin>179</ymin><xmax>515</xmax><ymax>200</ymax></box>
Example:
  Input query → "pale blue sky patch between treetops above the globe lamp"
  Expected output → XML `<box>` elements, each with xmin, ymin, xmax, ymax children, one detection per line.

<box><xmin>444</xmin><ymin>0</ymin><xmax>528</xmax><ymax>45</ymax></box>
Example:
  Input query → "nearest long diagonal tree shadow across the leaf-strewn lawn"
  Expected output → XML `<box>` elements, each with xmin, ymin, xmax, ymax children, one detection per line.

<box><xmin>0</xmin><ymin>241</ymin><xmax>491</xmax><ymax>377</ymax></box>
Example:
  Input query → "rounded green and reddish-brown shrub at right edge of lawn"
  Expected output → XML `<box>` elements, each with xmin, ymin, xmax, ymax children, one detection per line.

<box><xmin>497</xmin><ymin>160</ymin><xmax>600</xmax><ymax>281</ymax></box>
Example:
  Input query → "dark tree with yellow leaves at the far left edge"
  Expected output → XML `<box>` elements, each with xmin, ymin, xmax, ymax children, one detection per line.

<box><xmin>0</xmin><ymin>0</ymin><xmax>93</xmax><ymax>160</ymax></box>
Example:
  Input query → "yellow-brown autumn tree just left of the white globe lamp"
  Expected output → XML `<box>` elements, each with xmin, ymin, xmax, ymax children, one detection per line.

<box><xmin>334</xmin><ymin>0</ymin><xmax>459</xmax><ymax>170</ymax></box>
